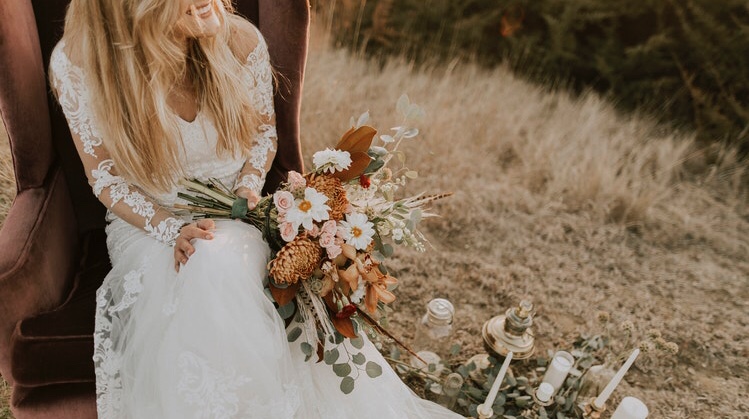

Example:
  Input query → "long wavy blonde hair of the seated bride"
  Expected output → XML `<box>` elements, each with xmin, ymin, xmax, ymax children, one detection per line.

<box><xmin>55</xmin><ymin>0</ymin><xmax>262</xmax><ymax>193</ymax></box>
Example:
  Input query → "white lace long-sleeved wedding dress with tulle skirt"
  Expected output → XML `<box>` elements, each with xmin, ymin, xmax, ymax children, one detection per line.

<box><xmin>50</xmin><ymin>23</ymin><xmax>459</xmax><ymax>419</ymax></box>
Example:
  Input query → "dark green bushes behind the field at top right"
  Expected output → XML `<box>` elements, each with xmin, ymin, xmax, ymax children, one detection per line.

<box><xmin>314</xmin><ymin>0</ymin><xmax>749</xmax><ymax>152</ymax></box>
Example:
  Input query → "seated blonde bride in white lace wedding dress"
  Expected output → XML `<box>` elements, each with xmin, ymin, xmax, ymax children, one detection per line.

<box><xmin>50</xmin><ymin>0</ymin><xmax>459</xmax><ymax>419</ymax></box>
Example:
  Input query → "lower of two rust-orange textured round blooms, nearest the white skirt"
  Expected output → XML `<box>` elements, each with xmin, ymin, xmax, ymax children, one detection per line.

<box><xmin>268</xmin><ymin>235</ymin><xmax>322</xmax><ymax>284</ymax></box>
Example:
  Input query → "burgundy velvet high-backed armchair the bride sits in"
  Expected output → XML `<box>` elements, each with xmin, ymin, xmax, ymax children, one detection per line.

<box><xmin>0</xmin><ymin>0</ymin><xmax>309</xmax><ymax>419</ymax></box>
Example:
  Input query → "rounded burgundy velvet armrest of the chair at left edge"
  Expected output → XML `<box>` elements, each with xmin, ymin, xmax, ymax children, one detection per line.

<box><xmin>0</xmin><ymin>165</ymin><xmax>79</xmax><ymax>384</ymax></box>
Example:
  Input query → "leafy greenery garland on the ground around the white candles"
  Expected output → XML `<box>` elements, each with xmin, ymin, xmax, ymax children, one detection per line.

<box><xmin>386</xmin><ymin>311</ymin><xmax>679</xmax><ymax>419</ymax></box>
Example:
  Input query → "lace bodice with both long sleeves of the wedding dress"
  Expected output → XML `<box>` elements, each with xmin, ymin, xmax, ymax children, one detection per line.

<box><xmin>50</xmin><ymin>26</ymin><xmax>277</xmax><ymax>245</ymax></box>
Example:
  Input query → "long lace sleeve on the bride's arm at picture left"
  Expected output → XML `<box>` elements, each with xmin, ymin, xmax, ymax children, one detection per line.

<box><xmin>50</xmin><ymin>42</ymin><xmax>185</xmax><ymax>246</ymax></box>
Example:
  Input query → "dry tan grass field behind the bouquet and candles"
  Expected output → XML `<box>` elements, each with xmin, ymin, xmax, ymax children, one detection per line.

<box><xmin>0</xmin><ymin>15</ymin><xmax>749</xmax><ymax>418</ymax></box>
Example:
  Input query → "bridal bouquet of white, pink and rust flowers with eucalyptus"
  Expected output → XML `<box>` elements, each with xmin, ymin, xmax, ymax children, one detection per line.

<box><xmin>177</xmin><ymin>95</ymin><xmax>447</xmax><ymax>393</ymax></box>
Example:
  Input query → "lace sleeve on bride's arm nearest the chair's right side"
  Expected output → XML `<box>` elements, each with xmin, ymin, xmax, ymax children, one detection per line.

<box><xmin>234</xmin><ymin>28</ymin><xmax>277</xmax><ymax>195</ymax></box>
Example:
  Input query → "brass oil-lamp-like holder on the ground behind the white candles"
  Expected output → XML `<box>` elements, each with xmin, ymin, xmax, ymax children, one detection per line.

<box><xmin>481</xmin><ymin>301</ymin><xmax>535</xmax><ymax>359</ymax></box>
